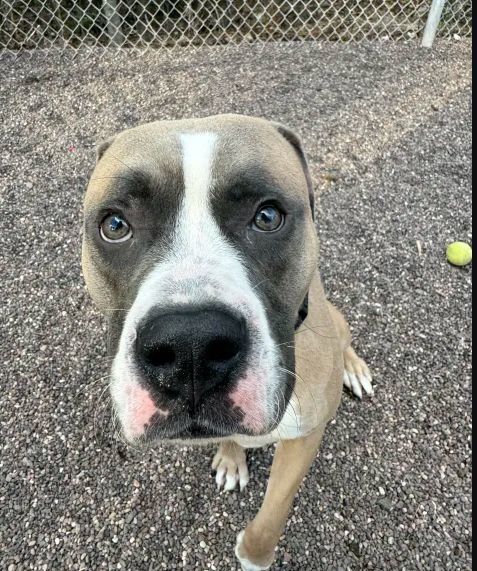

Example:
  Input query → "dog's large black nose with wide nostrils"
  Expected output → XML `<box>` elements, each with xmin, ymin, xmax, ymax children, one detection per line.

<box><xmin>136</xmin><ymin>309</ymin><xmax>248</xmax><ymax>409</ymax></box>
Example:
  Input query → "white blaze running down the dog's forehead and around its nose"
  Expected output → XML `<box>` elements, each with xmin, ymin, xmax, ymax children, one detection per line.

<box><xmin>112</xmin><ymin>133</ymin><xmax>279</xmax><ymax>440</ymax></box>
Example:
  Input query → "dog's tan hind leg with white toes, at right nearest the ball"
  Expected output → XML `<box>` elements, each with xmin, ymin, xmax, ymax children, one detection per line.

<box><xmin>328</xmin><ymin>303</ymin><xmax>374</xmax><ymax>398</ymax></box>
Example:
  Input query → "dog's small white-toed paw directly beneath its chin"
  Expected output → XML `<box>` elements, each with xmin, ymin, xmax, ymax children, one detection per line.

<box><xmin>212</xmin><ymin>442</ymin><xmax>249</xmax><ymax>492</ymax></box>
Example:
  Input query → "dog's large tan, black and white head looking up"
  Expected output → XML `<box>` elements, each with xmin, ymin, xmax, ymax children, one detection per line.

<box><xmin>83</xmin><ymin>116</ymin><xmax>317</xmax><ymax>441</ymax></box>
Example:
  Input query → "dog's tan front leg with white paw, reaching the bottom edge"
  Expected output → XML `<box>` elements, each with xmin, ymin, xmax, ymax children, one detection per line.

<box><xmin>235</xmin><ymin>426</ymin><xmax>325</xmax><ymax>571</ymax></box>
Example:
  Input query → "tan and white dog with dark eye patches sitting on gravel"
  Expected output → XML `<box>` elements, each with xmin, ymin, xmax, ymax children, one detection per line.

<box><xmin>82</xmin><ymin>115</ymin><xmax>373</xmax><ymax>571</ymax></box>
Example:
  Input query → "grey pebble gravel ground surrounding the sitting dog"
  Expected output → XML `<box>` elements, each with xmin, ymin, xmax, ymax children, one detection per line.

<box><xmin>0</xmin><ymin>41</ymin><xmax>472</xmax><ymax>571</ymax></box>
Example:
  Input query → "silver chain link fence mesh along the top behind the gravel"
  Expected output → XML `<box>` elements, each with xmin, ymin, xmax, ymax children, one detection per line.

<box><xmin>0</xmin><ymin>0</ymin><xmax>472</xmax><ymax>52</ymax></box>
